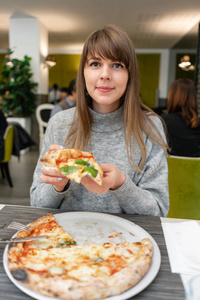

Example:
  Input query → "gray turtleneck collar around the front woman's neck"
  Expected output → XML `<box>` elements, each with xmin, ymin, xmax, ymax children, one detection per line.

<box><xmin>89</xmin><ymin>105</ymin><xmax>124</xmax><ymax>132</ymax></box>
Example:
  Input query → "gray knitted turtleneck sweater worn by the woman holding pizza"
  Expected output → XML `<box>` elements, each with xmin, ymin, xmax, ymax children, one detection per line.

<box><xmin>30</xmin><ymin>107</ymin><xmax>169</xmax><ymax>216</ymax></box>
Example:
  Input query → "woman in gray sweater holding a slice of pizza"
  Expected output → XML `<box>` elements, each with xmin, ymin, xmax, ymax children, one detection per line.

<box><xmin>31</xmin><ymin>25</ymin><xmax>169</xmax><ymax>216</ymax></box>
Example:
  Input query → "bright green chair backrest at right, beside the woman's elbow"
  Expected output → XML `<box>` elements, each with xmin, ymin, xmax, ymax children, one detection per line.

<box><xmin>167</xmin><ymin>156</ymin><xmax>200</xmax><ymax>220</ymax></box>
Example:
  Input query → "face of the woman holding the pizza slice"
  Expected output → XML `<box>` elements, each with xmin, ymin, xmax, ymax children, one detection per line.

<box><xmin>84</xmin><ymin>55</ymin><xmax>128</xmax><ymax>113</ymax></box>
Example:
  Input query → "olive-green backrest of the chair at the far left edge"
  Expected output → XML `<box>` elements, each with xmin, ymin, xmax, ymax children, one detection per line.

<box><xmin>2</xmin><ymin>125</ymin><xmax>14</xmax><ymax>163</ymax></box>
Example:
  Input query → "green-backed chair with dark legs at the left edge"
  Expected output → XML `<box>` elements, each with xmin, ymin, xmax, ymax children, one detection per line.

<box><xmin>0</xmin><ymin>125</ymin><xmax>14</xmax><ymax>187</ymax></box>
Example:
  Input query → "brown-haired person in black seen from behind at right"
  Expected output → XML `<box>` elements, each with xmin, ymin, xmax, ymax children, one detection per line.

<box><xmin>161</xmin><ymin>79</ymin><xmax>200</xmax><ymax>157</ymax></box>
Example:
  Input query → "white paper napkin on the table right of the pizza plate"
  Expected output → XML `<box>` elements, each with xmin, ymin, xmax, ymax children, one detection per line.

<box><xmin>162</xmin><ymin>221</ymin><xmax>200</xmax><ymax>274</ymax></box>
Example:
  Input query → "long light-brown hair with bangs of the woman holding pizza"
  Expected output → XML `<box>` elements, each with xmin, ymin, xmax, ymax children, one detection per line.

<box><xmin>65</xmin><ymin>25</ymin><xmax>168</xmax><ymax>172</ymax></box>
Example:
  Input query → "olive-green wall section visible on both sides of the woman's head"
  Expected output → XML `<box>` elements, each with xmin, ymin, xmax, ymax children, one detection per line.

<box><xmin>49</xmin><ymin>53</ymin><xmax>160</xmax><ymax>108</ymax></box>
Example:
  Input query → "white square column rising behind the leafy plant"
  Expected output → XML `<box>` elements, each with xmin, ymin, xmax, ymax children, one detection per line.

<box><xmin>9</xmin><ymin>15</ymin><xmax>49</xmax><ymax>94</ymax></box>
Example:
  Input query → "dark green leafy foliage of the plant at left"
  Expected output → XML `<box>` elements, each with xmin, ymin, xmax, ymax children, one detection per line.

<box><xmin>0</xmin><ymin>51</ymin><xmax>38</xmax><ymax>117</ymax></box>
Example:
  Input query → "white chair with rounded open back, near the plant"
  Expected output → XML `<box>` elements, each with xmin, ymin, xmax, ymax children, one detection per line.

<box><xmin>36</xmin><ymin>103</ymin><xmax>54</xmax><ymax>150</ymax></box>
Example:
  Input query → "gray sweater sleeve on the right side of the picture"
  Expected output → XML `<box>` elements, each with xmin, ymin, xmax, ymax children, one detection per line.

<box><xmin>110</xmin><ymin>122</ymin><xmax>169</xmax><ymax>217</ymax></box>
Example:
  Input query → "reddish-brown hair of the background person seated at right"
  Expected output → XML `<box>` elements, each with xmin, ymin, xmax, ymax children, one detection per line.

<box><xmin>167</xmin><ymin>79</ymin><xmax>199</xmax><ymax>128</ymax></box>
